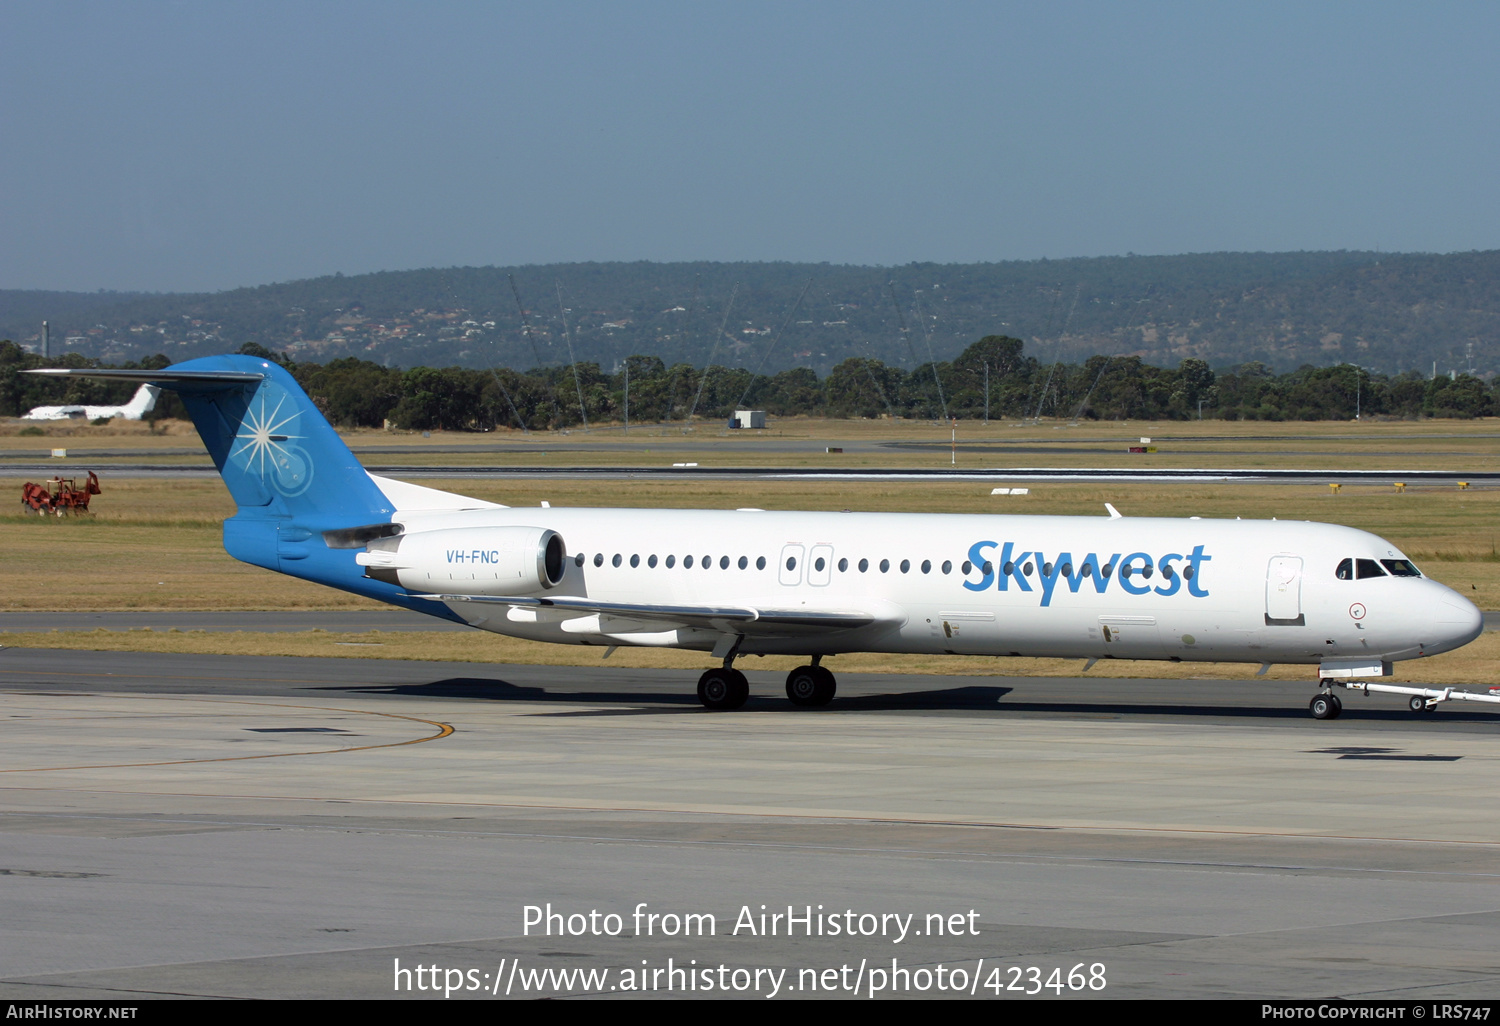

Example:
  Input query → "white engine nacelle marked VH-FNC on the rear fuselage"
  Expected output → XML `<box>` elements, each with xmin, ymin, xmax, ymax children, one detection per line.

<box><xmin>354</xmin><ymin>527</ymin><xmax>567</xmax><ymax>596</ymax></box>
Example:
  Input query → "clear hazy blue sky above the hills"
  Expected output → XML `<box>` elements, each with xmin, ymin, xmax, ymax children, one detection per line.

<box><xmin>0</xmin><ymin>0</ymin><xmax>1500</xmax><ymax>291</ymax></box>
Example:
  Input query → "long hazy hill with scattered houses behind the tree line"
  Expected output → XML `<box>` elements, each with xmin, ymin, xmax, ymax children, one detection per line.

<box><xmin>0</xmin><ymin>251</ymin><xmax>1500</xmax><ymax>378</ymax></box>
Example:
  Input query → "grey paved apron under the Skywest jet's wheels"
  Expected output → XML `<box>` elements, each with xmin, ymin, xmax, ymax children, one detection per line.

<box><xmin>0</xmin><ymin>650</ymin><xmax>1500</xmax><ymax>1001</ymax></box>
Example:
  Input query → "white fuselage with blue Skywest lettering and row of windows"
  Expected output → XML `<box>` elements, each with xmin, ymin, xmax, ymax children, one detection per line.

<box><xmin>398</xmin><ymin>509</ymin><xmax>1484</xmax><ymax>663</ymax></box>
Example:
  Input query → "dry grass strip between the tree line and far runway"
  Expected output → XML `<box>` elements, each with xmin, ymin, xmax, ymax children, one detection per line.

<box><xmin>0</xmin><ymin>417</ymin><xmax>1500</xmax><ymax>473</ymax></box>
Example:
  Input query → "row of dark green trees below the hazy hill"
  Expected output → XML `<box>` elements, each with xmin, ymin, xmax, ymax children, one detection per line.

<box><xmin>0</xmin><ymin>335</ymin><xmax>1500</xmax><ymax>431</ymax></box>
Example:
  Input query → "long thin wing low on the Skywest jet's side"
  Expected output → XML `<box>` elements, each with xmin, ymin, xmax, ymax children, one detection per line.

<box><xmin>416</xmin><ymin>594</ymin><xmax>899</xmax><ymax>638</ymax></box>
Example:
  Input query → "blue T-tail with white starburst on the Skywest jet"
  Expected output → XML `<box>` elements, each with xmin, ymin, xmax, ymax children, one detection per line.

<box><xmin>32</xmin><ymin>356</ymin><xmax>452</xmax><ymax>617</ymax></box>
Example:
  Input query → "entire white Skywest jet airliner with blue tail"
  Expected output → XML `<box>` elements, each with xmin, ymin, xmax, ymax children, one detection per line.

<box><xmin>33</xmin><ymin>356</ymin><xmax>1500</xmax><ymax>719</ymax></box>
